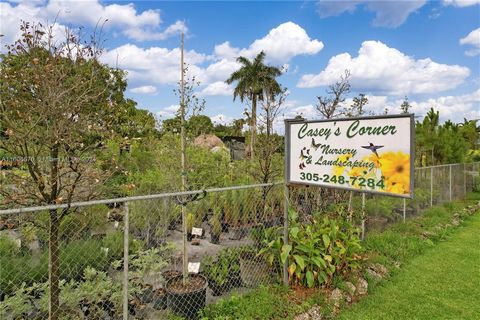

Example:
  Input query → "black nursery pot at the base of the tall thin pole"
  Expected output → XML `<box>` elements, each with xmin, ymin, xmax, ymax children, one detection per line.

<box><xmin>165</xmin><ymin>274</ymin><xmax>208</xmax><ymax>319</ymax></box>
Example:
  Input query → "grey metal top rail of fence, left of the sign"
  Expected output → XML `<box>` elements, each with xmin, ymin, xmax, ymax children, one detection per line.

<box><xmin>0</xmin><ymin>181</ymin><xmax>283</xmax><ymax>215</ymax></box>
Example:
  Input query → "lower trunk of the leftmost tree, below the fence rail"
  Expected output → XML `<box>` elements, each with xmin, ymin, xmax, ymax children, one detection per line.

<box><xmin>48</xmin><ymin>210</ymin><xmax>60</xmax><ymax>320</ymax></box>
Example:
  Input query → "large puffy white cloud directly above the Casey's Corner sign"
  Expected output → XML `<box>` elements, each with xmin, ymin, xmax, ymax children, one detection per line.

<box><xmin>297</xmin><ymin>41</ymin><xmax>470</xmax><ymax>96</ymax></box>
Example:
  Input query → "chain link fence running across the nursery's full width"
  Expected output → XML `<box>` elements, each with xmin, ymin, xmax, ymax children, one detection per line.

<box><xmin>0</xmin><ymin>163</ymin><xmax>480</xmax><ymax>319</ymax></box>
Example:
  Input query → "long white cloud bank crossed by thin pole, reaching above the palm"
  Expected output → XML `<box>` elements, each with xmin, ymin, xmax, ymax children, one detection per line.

<box><xmin>102</xmin><ymin>22</ymin><xmax>323</xmax><ymax>87</ymax></box>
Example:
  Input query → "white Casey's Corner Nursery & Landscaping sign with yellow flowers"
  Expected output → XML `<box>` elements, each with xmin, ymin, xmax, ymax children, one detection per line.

<box><xmin>285</xmin><ymin>114</ymin><xmax>415</xmax><ymax>198</ymax></box>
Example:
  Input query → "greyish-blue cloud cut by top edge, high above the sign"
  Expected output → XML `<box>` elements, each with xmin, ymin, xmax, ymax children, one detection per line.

<box><xmin>318</xmin><ymin>0</ymin><xmax>427</xmax><ymax>27</ymax></box>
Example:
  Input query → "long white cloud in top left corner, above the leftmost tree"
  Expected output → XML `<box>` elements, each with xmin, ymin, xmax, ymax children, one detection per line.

<box><xmin>0</xmin><ymin>0</ymin><xmax>188</xmax><ymax>43</ymax></box>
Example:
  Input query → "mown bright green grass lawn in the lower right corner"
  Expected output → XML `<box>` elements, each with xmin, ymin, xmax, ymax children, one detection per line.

<box><xmin>339</xmin><ymin>214</ymin><xmax>480</xmax><ymax>320</ymax></box>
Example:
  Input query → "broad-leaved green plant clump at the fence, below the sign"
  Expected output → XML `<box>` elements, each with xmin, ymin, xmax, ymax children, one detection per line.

<box><xmin>259</xmin><ymin>211</ymin><xmax>362</xmax><ymax>288</ymax></box>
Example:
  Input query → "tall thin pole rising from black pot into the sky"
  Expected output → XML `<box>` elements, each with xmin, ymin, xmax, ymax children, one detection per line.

<box><xmin>180</xmin><ymin>33</ymin><xmax>188</xmax><ymax>283</ymax></box>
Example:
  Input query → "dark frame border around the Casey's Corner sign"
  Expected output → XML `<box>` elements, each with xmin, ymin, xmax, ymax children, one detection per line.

<box><xmin>284</xmin><ymin>113</ymin><xmax>415</xmax><ymax>199</ymax></box>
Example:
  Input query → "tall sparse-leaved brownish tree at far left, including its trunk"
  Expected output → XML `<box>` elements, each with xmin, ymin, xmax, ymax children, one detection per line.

<box><xmin>0</xmin><ymin>23</ymin><xmax>144</xmax><ymax>319</ymax></box>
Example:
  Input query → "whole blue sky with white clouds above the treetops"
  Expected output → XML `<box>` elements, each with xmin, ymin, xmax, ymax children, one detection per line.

<box><xmin>0</xmin><ymin>0</ymin><xmax>480</xmax><ymax>130</ymax></box>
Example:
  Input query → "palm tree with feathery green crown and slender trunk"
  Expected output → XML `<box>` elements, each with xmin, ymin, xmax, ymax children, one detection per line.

<box><xmin>226</xmin><ymin>51</ymin><xmax>282</xmax><ymax>159</ymax></box>
